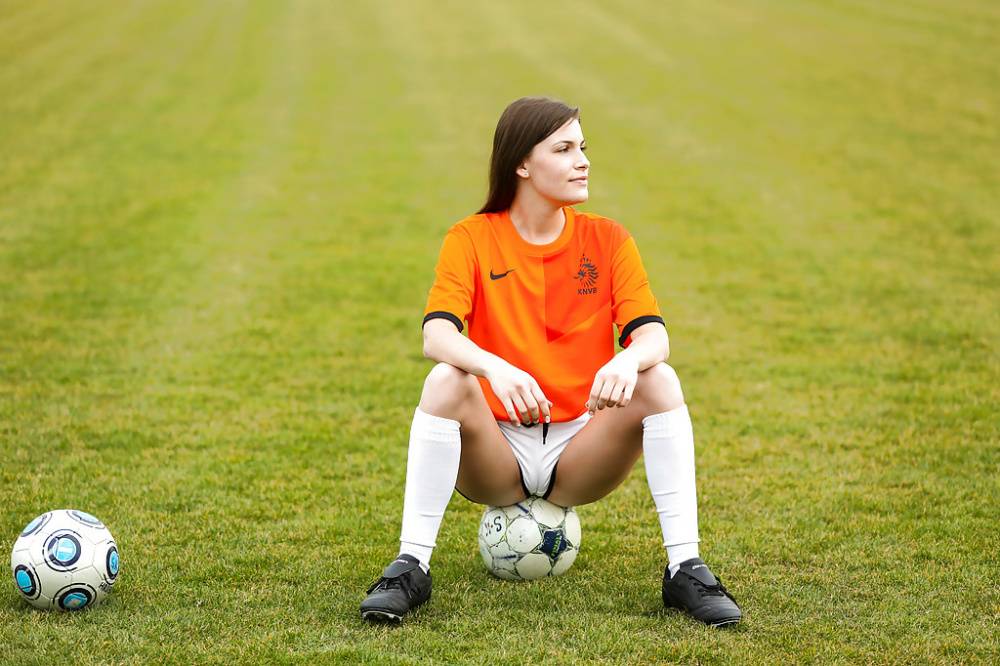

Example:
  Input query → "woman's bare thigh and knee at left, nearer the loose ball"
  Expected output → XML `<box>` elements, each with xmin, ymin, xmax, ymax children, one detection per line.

<box><xmin>420</xmin><ymin>363</ymin><xmax>525</xmax><ymax>506</ymax></box>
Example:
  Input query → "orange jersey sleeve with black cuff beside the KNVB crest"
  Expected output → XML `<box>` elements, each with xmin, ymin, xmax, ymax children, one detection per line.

<box><xmin>611</xmin><ymin>236</ymin><xmax>663</xmax><ymax>347</ymax></box>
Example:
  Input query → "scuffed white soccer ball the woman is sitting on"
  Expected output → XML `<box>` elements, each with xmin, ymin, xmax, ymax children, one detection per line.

<box><xmin>479</xmin><ymin>497</ymin><xmax>581</xmax><ymax>580</ymax></box>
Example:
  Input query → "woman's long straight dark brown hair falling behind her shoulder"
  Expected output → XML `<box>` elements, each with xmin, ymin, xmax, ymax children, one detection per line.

<box><xmin>479</xmin><ymin>97</ymin><xmax>580</xmax><ymax>213</ymax></box>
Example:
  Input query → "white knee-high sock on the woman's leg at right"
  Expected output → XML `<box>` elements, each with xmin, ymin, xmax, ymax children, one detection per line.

<box><xmin>642</xmin><ymin>405</ymin><xmax>699</xmax><ymax>576</ymax></box>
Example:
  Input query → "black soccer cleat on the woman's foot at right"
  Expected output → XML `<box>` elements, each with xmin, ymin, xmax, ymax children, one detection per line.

<box><xmin>663</xmin><ymin>557</ymin><xmax>743</xmax><ymax>627</ymax></box>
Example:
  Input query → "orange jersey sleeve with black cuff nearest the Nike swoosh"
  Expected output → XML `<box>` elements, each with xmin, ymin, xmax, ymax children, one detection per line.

<box><xmin>424</xmin><ymin>225</ymin><xmax>476</xmax><ymax>332</ymax></box>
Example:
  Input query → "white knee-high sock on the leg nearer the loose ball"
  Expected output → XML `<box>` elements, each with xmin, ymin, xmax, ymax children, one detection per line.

<box><xmin>399</xmin><ymin>407</ymin><xmax>462</xmax><ymax>571</ymax></box>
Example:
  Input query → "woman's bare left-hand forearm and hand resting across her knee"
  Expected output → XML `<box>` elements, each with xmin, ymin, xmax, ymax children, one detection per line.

<box><xmin>424</xmin><ymin>319</ymin><xmax>552</xmax><ymax>426</ymax></box>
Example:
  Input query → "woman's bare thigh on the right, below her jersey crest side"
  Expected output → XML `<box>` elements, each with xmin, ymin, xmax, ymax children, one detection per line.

<box><xmin>549</xmin><ymin>402</ymin><xmax>644</xmax><ymax>506</ymax></box>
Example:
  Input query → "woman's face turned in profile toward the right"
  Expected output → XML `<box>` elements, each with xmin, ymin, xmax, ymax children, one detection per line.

<box><xmin>517</xmin><ymin>118</ymin><xmax>590</xmax><ymax>206</ymax></box>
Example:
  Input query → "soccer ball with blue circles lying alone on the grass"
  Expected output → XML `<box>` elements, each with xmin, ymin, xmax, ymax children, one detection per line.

<box><xmin>10</xmin><ymin>509</ymin><xmax>121</xmax><ymax>610</ymax></box>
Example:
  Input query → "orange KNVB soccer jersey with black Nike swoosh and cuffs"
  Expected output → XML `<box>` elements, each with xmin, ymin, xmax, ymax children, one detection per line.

<box><xmin>424</xmin><ymin>206</ymin><xmax>663</xmax><ymax>421</ymax></box>
